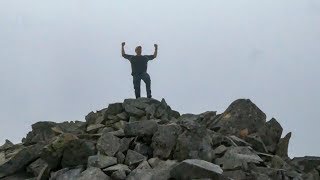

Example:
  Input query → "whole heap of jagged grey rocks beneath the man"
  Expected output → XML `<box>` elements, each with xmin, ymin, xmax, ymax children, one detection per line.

<box><xmin>0</xmin><ymin>98</ymin><xmax>320</xmax><ymax>180</ymax></box>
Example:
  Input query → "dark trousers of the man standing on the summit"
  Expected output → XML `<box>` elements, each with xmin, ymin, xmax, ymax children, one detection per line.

<box><xmin>132</xmin><ymin>73</ymin><xmax>151</xmax><ymax>98</ymax></box>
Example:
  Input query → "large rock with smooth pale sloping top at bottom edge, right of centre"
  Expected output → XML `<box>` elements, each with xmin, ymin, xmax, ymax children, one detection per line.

<box><xmin>170</xmin><ymin>159</ymin><xmax>227</xmax><ymax>180</ymax></box>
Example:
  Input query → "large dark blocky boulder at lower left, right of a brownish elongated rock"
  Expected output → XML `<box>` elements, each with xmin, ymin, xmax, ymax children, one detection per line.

<box><xmin>61</xmin><ymin>139</ymin><xmax>96</xmax><ymax>167</ymax></box>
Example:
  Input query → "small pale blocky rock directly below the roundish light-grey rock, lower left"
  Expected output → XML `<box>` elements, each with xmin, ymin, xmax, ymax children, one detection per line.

<box><xmin>88</xmin><ymin>155</ymin><xmax>117</xmax><ymax>169</ymax></box>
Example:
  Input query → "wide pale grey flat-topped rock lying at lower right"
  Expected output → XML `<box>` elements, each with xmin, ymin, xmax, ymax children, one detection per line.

<box><xmin>215</xmin><ymin>147</ymin><xmax>263</xmax><ymax>170</ymax></box>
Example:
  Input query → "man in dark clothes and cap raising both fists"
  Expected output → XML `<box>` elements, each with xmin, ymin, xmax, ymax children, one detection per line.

<box><xmin>121</xmin><ymin>42</ymin><xmax>158</xmax><ymax>98</ymax></box>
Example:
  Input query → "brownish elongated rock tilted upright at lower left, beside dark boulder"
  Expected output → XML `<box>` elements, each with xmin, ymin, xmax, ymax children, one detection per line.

<box><xmin>41</xmin><ymin>133</ymin><xmax>78</xmax><ymax>169</ymax></box>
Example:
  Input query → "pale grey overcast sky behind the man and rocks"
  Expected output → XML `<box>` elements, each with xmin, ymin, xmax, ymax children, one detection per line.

<box><xmin>0</xmin><ymin>0</ymin><xmax>320</xmax><ymax>156</ymax></box>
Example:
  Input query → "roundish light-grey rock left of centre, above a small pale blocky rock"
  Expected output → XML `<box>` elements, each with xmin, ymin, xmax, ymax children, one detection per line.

<box><xmin>97</xmin><ymin>133</ymin><xmax>120</xmax><ymax>156</ymax></box>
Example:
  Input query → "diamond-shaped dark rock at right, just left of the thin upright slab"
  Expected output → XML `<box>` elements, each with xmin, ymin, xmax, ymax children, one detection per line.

<box><xmin>258</xmin><ymin>118</ymin><xmax>283</xmax><ymax>152</ymax></box>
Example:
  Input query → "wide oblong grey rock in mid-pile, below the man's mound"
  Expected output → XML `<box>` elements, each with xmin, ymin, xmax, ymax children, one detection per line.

<box><xmin>124</xmin><ymin>120</ymin><xmax>158</xmax><ymax>136</ymax></box>
